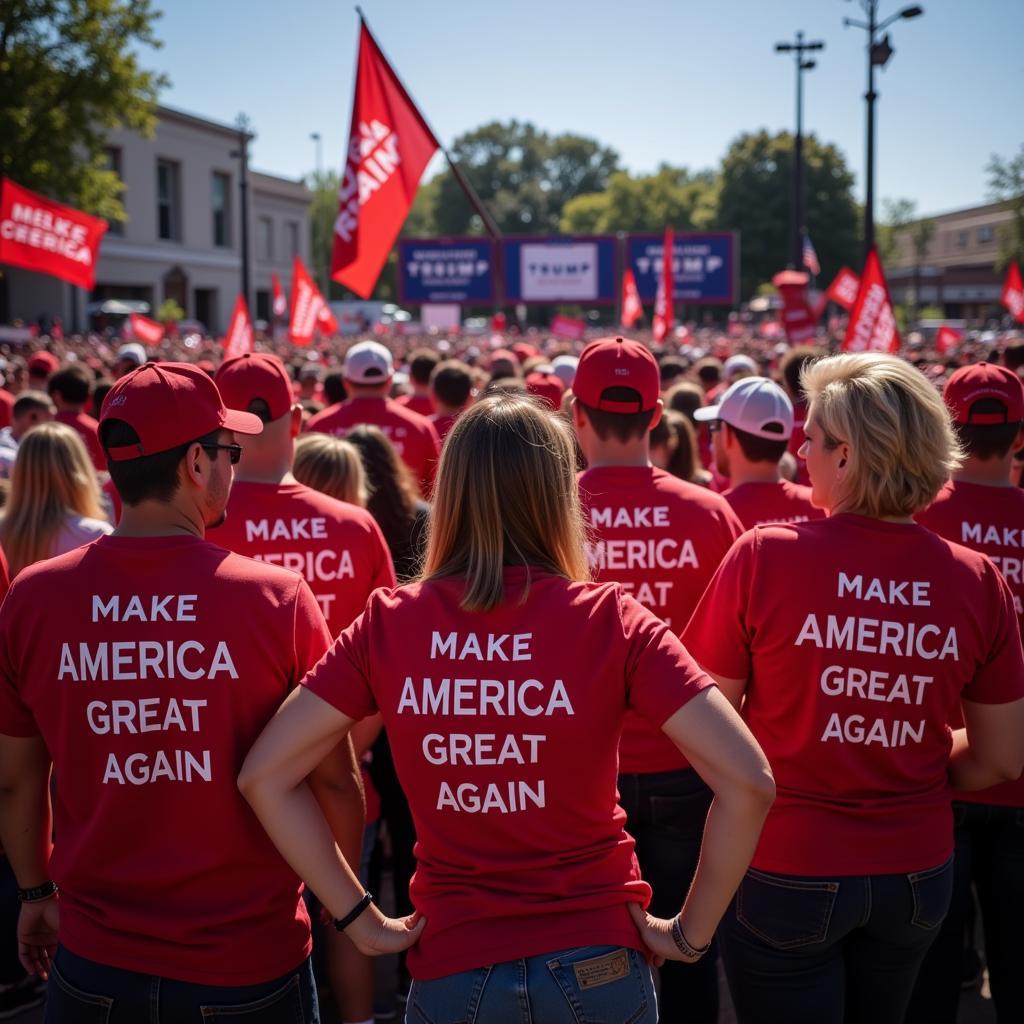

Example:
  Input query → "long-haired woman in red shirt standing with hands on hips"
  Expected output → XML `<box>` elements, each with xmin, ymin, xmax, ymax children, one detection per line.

<box><xmin>239</xmin><ymin>395</ymin><xmax>773</xmax><ymax>1024</ymax></box>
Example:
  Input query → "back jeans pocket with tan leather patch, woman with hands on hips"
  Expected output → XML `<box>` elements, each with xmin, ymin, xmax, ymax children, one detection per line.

<box><xmin>547</xmin><ymin>946</ymin><xmax>657</xmax><ymax>1024</ymax></box>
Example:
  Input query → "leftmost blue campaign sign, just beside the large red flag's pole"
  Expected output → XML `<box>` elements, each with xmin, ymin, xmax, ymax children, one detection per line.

<box><xmin>398</xmin><ymin>239</ymin><xmax>495</xmax><ymax>305</ymax></box>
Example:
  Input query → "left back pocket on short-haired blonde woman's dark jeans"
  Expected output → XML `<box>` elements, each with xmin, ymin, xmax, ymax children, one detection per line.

<box><xmin>735</xmin><ymin>867</ymin><xmax>839</xmax><ymax>949</ymax></box>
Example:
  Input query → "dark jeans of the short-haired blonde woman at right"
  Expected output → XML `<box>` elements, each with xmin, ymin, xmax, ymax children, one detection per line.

<box><xmin>719</xmin><ymin>857</ymin><xmax>953</xmax><ymax>1024</ymax></box>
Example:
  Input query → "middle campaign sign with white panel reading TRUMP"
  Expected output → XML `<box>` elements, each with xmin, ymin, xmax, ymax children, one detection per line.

<box><xmin>502</xmin><ymin>237</ymin><xmax>615</xmax><ymax>304</ymax></box>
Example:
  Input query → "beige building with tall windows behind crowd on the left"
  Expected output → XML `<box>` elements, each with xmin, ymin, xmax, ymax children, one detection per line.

<box><xmin>6</xmin><ymin>106</ymin><xmax>311</xmax><ymax>334</ymax></box>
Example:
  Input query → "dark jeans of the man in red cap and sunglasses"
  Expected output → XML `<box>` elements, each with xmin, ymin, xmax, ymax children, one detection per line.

<box><xmin>45</xmin><ymin>946</ymin><xmax>319</xmax><ymax>1024</ymax></box>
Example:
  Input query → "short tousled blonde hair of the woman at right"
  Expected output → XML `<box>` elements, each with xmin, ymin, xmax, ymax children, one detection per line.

<box><xmin>800</xmin><ymin>352</ymin><xmax>964</xmax><ymax>518</ymax></box>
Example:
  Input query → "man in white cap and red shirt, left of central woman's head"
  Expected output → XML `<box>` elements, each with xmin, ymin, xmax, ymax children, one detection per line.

<box><xmin>305</xmin><ymin>341</ymin><xmax>440</xmax><ymax>495</ymax></box>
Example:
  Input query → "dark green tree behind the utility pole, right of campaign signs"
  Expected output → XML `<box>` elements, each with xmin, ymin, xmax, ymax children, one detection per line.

<box><xmin>716</xmin><ymin>130</ymin><xmax>859</xmax><ymax>296</ymax></box>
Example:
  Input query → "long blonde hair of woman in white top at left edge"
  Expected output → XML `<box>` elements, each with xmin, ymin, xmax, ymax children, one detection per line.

<box><xmin>0</xmin><ymin>423</ymin><xmax>106</xmax><ymax>578</ymax></box>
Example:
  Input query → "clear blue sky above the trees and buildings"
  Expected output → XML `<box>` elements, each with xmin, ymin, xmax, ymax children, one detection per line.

<box><xmin>151</xmin><ymin>0</ymin><xmax>1024</xmax><ymax>216</ymax></box>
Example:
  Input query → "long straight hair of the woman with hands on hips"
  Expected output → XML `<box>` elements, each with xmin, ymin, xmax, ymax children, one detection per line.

<box><xmin>423</xmin><ymin>394</ymin><xmax>590</xmax><ymax>611</ymax></box>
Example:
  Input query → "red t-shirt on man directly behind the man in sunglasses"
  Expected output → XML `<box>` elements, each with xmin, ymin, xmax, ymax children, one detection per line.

<box><xmin>208</xmin><ymin>480</ymin><xmax>395</xmax><ymax>636</ymax></box>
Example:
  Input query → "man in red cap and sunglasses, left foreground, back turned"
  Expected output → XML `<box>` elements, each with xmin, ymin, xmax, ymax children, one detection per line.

<box><xmin>0</xmin><ymin>362</ymin><xmax>361</xmax><ymax>1022</ymax></box>
